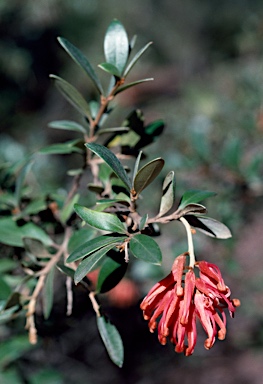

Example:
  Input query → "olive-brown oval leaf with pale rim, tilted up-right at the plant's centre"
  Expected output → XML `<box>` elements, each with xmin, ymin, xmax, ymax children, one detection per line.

<box><xmin>133</xmin><ymin>157</ymin><xmax>164</xmax><ymax>195</ymax></box>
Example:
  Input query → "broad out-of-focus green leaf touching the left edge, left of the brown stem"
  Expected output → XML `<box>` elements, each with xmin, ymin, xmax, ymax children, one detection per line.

<box><xmin>0</xmin><ymin>217</ymin><xmax>53</xmax><ymax>247</ymax></box>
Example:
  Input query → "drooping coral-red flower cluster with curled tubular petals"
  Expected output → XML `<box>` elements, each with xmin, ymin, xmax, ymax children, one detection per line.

<box><xmin>141</xmin><ymin>253</ymin><xmax>240</xmax><ymax>356</ymax></box>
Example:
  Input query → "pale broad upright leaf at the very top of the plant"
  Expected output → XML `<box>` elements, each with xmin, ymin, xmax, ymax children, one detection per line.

<box><xmin>104</xmin><ymin>20</ymin><xmax>129</xmax><ymax>74</ymax></box>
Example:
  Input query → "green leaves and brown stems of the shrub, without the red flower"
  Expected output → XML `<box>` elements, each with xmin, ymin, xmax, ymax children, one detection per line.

<box><xmin>0</xmin><ymin>20</ymin><xmax>254</xmax><ymax>367</ymax></box>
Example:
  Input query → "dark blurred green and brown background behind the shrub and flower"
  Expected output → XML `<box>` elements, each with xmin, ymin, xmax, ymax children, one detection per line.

<box><xmin>0</xmin><ymin>0</ymin><xmax>263</xmax><ymax>384</ymax></box>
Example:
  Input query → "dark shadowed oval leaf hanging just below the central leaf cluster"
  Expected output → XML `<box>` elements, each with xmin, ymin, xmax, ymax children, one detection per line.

<box><xmin>96</xmin><ymin>252</ymin><xmax>128</xmax><ymax>293</ymax></box>
